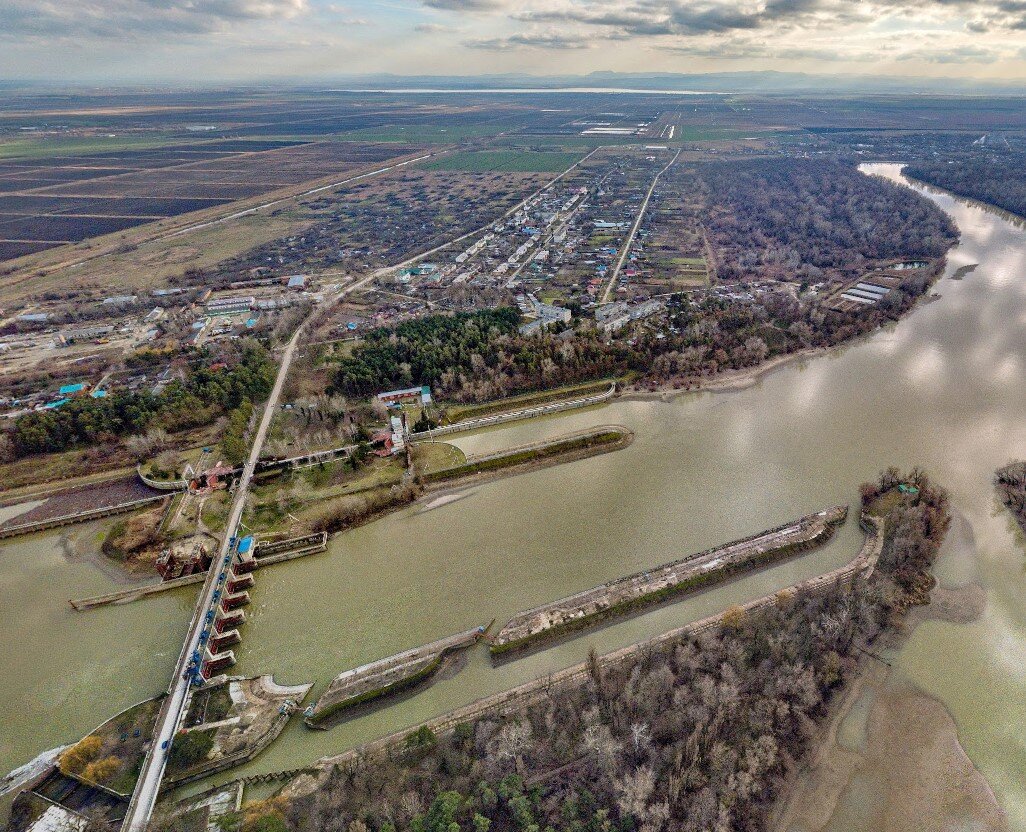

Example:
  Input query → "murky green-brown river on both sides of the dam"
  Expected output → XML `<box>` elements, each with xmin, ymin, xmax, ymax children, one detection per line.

<box><xmin>0</xmin><ymin>164</ymin><xmax>1026</xmax><ymax>830</ymax></box>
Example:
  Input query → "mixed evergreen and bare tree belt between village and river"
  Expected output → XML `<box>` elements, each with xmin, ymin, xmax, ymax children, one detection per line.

<box><xmin>329</xmin><ymin>272</ymin><xmax>933</xmax><ymax>402</ymax></box>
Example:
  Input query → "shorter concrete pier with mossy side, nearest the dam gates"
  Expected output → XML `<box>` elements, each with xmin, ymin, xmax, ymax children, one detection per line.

<box><xmin>306</xmin><ymin>627</ymin><xmax>488</xmax><ymax>727</ymax></box>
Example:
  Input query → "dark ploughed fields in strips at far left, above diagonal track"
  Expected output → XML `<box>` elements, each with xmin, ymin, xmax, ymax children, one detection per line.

<box><xmin>0</xmin><ymin>137</ymin><xmax>428</xmax><ymax>261</ymax></box>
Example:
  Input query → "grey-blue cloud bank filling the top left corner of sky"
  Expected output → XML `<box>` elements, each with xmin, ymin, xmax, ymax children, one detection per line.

<box><xmin>0</xmin><ymin>0</ymin><xmax>309</xmax><ymax>39</ymax></box>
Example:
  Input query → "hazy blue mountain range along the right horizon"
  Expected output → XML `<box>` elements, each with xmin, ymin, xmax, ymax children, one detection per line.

<box><xmin>332</xmin><ymin>71</ymin><xmax>1026</xmax><ymax>95</ymax></box>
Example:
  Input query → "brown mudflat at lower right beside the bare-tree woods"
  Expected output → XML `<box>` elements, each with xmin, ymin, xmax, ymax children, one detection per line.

<box><xmin>771</xmin><ymin>584</ymin><xmax>1009</xmax><ymax>832</ymax></box>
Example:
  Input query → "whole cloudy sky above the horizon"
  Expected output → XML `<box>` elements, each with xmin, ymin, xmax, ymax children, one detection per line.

<box><xmin>6</xmin><ymin>0</ymin><xmax>1026</xmax><ymax>84</ymax></box>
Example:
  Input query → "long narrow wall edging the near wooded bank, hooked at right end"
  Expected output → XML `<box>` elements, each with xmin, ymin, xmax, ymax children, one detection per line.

<box><xmin>281</xmin><ymin>515</ymin><xmax>884</xmax><ymax>798</ymax></box>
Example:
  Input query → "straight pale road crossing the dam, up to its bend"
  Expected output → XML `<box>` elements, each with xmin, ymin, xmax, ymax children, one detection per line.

<box><xmin>122</xmin><ymin>321</ymin><xmax>306</xmax><ymax>832</ymax></box>
